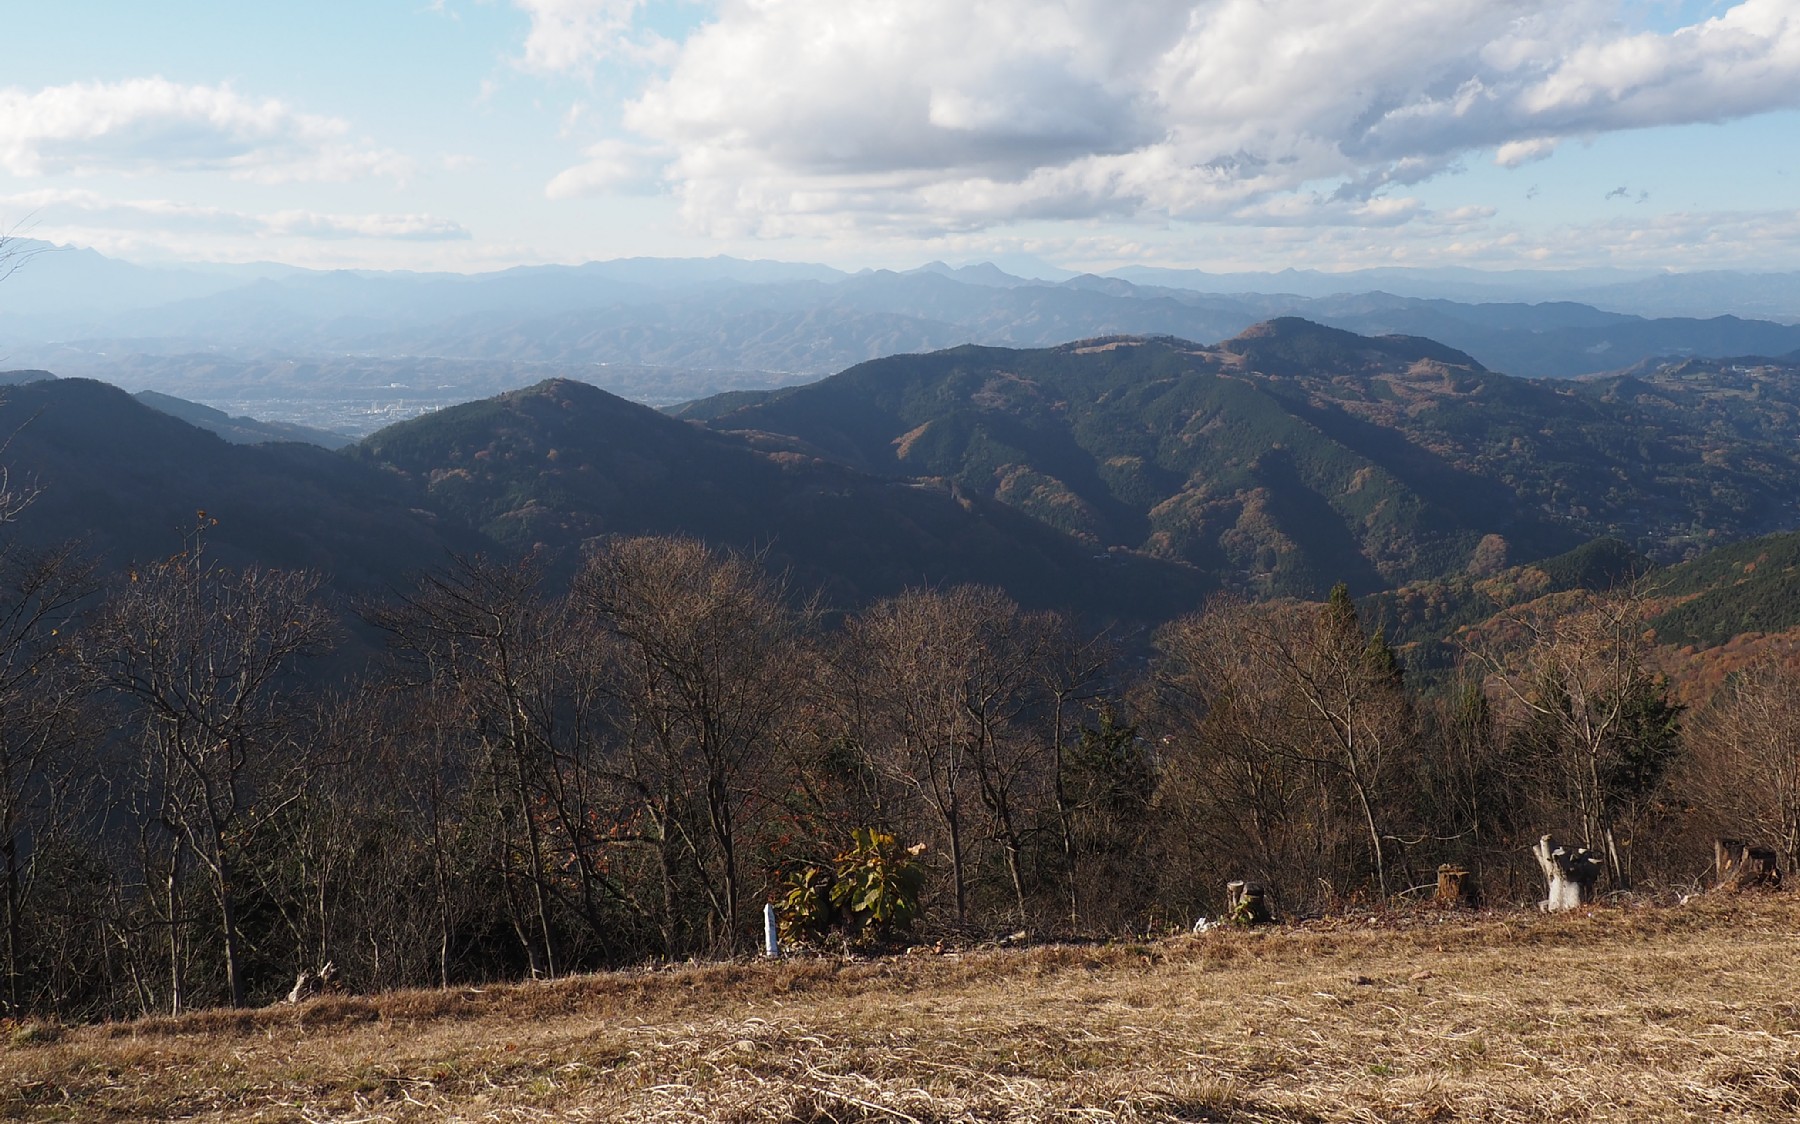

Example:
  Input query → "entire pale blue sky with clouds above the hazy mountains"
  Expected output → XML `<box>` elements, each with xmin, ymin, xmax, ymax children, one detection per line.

<box><xmin>0</xmin><ymin>0</ymin><xmax>1800</xmax><ymax>272</ymax></box>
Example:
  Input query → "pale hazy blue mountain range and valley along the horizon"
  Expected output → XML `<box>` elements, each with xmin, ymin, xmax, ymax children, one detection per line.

<box><xmin>10</xmin><ymin>241</ymin><xmax>1800</xmax><ymax>434</ymax></box>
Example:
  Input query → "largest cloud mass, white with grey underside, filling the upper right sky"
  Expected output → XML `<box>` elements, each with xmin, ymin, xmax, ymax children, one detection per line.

<box><xmin>604</xmin><ymin>0</ymin><xmax>1800</xmax><ymax>236</ymax></box>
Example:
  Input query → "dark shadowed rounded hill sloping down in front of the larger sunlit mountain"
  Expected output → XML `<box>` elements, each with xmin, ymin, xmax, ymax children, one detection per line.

<box><xmin>353</xmin><ymin>380</ymin><xmax>1206</xmax><ymax>616</ymax></box>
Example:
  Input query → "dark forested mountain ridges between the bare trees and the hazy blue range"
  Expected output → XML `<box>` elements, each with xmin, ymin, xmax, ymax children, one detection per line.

<box><xmin>17</xmin><ymin>319</ymin><xmax>1800</xmax><ymax>645</ymax></box>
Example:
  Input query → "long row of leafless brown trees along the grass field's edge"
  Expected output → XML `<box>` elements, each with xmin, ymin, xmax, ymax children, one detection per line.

<box><xmin>0</xmin><ymin>537</ymin><xmax>1771</xmax><ymax>1018</ymax></box>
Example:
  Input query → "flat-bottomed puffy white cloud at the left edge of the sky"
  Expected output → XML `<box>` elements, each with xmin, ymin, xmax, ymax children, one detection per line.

<box><xmin>0</xmin><ymin>77</ymin><xmax>410</xmax><ymax>182</ymax></box>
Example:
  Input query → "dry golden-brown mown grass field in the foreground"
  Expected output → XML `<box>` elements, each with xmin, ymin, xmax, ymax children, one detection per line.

<box><xmin>0</xmin><ymin>895</ymin><xmax>1800</xmax><ymax>1124</ymax></box>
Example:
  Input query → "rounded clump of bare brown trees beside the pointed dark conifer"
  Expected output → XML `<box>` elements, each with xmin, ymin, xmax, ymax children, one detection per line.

<box><xmin>1152</xmin><ymin>587</ymin><xmax>1418</xmax><ymax>918</ymax></box>
